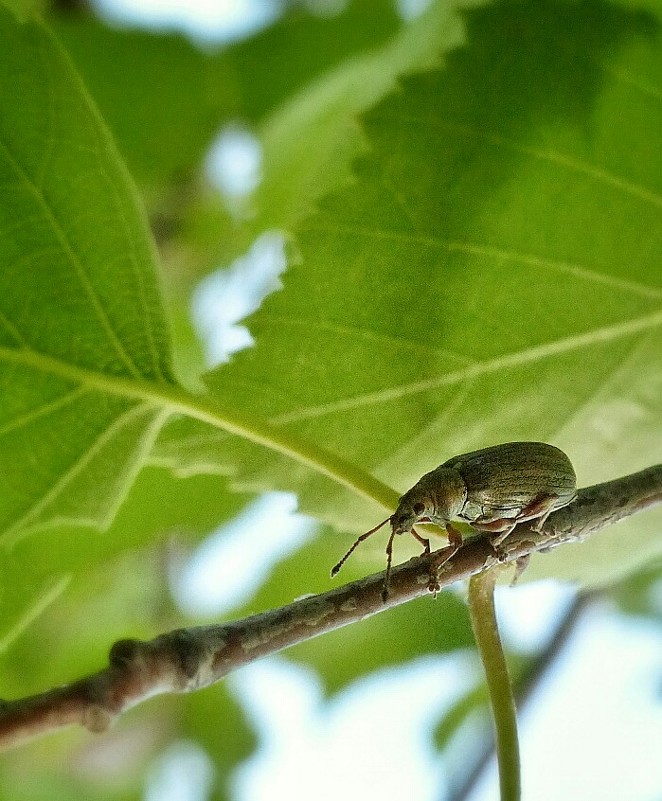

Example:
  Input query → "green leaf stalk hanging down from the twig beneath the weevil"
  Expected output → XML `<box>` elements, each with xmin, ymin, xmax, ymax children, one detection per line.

<box><xmin>469</xmin><ymin>568</ymin><xmax>521</xmax><ymax>801</ymax></box>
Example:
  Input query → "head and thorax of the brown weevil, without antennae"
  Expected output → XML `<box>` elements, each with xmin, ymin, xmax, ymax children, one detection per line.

<box><xmin>391</xmin><ymin>466</ymin><xmax>467</xmax><ymax>534</ymax></box>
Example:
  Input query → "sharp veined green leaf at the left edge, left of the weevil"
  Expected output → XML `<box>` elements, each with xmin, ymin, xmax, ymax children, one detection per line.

<box><xmin>0</xmin><ymin>10</ymin><xmax>172</xmax><ymax>541</ymax></box>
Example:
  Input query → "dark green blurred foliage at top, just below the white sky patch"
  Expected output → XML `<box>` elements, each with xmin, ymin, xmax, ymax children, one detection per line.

<box><xmin>50</xmin><ymin>0</ymin><xmax>398</xmax><ymax>191</ymax></box>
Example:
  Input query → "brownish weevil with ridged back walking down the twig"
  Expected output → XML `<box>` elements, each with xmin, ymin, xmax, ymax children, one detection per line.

<box><xmin>331</xmin><ymin>442</ymin><xmax>577</xmax><ymax>600</ymax></box>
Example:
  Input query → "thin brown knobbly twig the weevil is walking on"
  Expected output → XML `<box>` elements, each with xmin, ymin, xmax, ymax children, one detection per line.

<box><xmin>0</xmin><ymin>465</ymin><xmax>662</xmax><ymax>748</ymax></box>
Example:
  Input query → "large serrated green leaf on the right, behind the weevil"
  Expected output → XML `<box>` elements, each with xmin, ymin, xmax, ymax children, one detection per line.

<box><xmin>175</xmin><ymin>2</ymin><xmax>662</xmax><ymax>580</ymax></box>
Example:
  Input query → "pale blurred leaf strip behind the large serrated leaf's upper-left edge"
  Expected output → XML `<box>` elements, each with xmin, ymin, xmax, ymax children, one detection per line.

<box><xmin>176</xmin><ymin>0</ymin><xmax>462</xmax><ymax>272</ymax></box>
